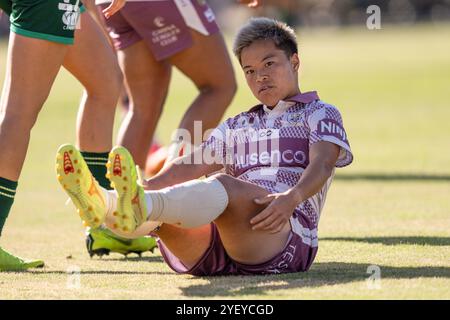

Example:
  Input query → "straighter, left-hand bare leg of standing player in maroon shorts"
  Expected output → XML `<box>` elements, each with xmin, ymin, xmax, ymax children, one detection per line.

<box><xmin>118</xmin><ymin>41</ymin><xmax>171</xmax><ymax>169</ymax></box>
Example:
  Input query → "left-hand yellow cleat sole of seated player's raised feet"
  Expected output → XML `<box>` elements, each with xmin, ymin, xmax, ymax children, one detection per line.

<box><xmin>56</xmin><ymin>144</ymin><xmax>107</xmax><ymax>228</ymax></box>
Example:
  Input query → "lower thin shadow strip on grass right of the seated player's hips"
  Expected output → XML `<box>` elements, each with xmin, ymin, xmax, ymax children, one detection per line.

<box><xmin>319</xmin><ymin>236</ymin><xmax>450</xmax><ymax>246</ymax></box>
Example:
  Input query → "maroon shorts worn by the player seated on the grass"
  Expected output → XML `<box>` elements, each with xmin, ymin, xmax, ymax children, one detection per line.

<box><xmin>159</xmin><ymin>213</ymin><xmax>318</xmax><ymax>276</ymax></box>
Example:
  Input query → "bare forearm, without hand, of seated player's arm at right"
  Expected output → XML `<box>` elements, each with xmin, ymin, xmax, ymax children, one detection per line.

<box><xmin>289</xmin><ymin>162</ymin><xmax>334</xmax><ymax>204</ymax></box>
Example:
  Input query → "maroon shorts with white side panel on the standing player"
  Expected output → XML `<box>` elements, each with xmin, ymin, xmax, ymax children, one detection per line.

<box><xmin>100</xmin><ymin>0</ymin><xmax>219</xmax><ymax>61</ymax></box>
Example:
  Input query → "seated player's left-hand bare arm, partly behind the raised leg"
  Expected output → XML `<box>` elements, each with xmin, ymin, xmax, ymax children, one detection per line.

<box><xmin>145</xmin><ymin>148</ymin><xmax>223</xmax><ymax>190</ymax></box>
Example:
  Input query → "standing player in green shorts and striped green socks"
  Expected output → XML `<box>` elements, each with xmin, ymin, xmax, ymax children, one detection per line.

<box><xmin>0</xmin><ymin>0</ymin><xmax>156</xmax><ymax>271</ymax></box>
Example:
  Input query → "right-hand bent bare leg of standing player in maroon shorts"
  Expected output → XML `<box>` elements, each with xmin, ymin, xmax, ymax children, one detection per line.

<box><xmin>169</xmin><ymin>30</ymin><xmax>237</xmax><ymax>151</ymax></box>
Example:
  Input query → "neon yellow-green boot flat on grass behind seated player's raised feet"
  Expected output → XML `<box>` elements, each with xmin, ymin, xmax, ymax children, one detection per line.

<box><xmin>86</xmin><ymin>228</ymin><xmax>157</xmax><ymax>258</ymax></box>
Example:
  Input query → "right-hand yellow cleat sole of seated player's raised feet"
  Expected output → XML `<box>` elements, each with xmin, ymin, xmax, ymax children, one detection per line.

<box><xmin>106</xmin><ymin>147</ymin><xmax>147</xmax><ymax>233</ymax></box>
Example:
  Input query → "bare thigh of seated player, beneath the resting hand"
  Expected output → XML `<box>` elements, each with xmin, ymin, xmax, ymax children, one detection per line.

<box><xmin>215</xmin><ymin>174</ymin><xmax>290</xmax><ymax>264</ymax></box>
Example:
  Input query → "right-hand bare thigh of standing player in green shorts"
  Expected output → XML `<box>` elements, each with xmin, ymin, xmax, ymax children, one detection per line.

<box><xmin>64</xmin><ymin>12</ymin><xmax>122</xmax><ymax>96</ymax></box>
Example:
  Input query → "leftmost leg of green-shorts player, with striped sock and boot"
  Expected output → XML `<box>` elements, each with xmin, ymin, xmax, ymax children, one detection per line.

<box><xmin>0</xmin><ymin>32</ymin><xmax>67</xmax><ymax>270</ymax></box>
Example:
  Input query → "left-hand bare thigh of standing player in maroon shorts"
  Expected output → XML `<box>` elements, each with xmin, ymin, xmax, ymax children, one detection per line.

<box><xmin>118</xmin><ymin>41</ymin><xmax>171</xmax><ymax>109</ymax></box>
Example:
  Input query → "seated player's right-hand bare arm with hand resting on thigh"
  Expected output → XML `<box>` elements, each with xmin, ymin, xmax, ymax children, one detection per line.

<box><xmin>250</xmin><ymin>141</ymin><xmax>340</xmax><ymax>233</ymax></box>
